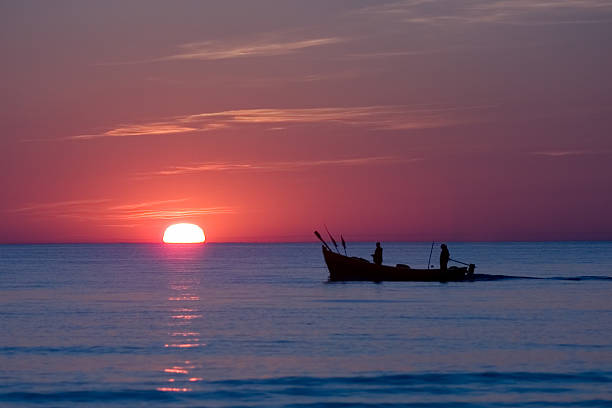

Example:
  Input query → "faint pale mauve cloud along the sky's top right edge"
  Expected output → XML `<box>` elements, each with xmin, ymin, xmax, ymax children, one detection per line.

<box><xmin>358</xmin><ymin>0</ymin><xmax>612</xmax><ymax>25</ymax></box>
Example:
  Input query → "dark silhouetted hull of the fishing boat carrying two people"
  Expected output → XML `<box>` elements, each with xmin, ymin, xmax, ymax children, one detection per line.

<box><xmin>322</xmin><ymin>247</ymin><xmax>472</xmax><ymax>282</ymax></box>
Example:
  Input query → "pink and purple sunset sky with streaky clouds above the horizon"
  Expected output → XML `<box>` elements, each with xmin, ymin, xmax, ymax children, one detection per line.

<box><xmin>0</xmin><ymin>0</ymin><xmax>612</xmax><ymax>243</ymax></box>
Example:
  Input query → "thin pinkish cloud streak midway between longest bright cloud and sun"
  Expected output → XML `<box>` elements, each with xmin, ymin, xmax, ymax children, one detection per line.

<box><xmin>138</xmin><ymin>156</ymin><xmax>422</xmax><ymax>177</ymax></box>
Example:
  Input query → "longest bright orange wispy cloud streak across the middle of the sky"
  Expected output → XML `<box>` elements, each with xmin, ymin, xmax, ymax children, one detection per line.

<box><xmin>67</xmin><ymin>105</ymin><xmax>492</xmax><ymax>140</ymax></box>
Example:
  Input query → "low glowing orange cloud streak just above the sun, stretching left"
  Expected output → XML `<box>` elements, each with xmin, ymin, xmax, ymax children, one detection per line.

<box><xmin>12</xmin><ymin>198</ymin><xmax>234</xmax><ymax>222</ymax></box>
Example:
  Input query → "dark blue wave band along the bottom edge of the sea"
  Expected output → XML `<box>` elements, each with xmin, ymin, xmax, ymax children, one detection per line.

<box><xmin>0</xmin><ymin>372</ymin><xmax>612</xmax><ymax>408</ymax></box>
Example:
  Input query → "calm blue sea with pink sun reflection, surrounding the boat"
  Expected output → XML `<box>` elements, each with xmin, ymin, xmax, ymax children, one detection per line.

<box><xmin>0</xmin><ymin>242</ymin><xmax>612</xmax><ymax>407</ymax></box>
